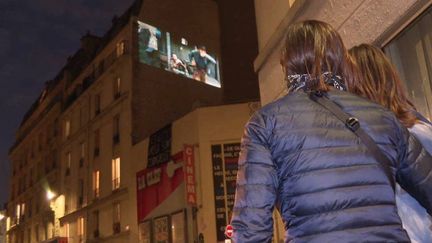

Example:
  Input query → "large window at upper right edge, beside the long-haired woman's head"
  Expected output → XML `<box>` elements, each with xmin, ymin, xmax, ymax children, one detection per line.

<box><xmin>384</xmin><ymin>7</ymin><xmax>432</xmax><ymax>119</ymax></box>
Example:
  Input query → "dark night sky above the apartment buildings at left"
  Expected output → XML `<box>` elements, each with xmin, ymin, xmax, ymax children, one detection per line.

<box><xmin>0</xmin><ymin>0</ymin><xmax>133</xmax><ymax>206</ymax></box>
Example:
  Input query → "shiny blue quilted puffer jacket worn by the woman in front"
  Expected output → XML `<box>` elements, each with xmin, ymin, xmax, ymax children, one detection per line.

<box><xmin>231</xmin><ymin>91</ymin><xmax>432</xmax><ymax>243</ymax></box>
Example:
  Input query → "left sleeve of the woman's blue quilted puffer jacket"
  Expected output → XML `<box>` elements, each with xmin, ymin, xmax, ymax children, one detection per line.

<box><xmin>231</xmin><ymin>113</ymin><xmax>278</xmax><ymax>243</ymax></box>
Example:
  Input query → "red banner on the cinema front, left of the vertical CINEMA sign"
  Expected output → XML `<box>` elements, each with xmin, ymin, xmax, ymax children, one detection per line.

<box><xmin>136</xmin><ymin>152</ymin><xmax>184</xmax><ymax>222</ymax></box>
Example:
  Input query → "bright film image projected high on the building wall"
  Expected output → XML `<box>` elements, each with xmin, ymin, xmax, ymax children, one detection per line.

<box><xmin>138</xmin><ymin>21</ymin><xmax>221</xmax><ymax>88</ymax></box>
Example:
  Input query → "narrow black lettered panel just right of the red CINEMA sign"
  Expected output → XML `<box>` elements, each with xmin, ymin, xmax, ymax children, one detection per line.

<box><xmin>211</xmin><ymin>144</ymin><xmax>227</xmax><ymax>242</ymax></box>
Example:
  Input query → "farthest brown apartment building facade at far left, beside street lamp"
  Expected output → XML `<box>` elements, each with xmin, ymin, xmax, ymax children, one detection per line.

<box><xmin>6</xmin><ymin>76</ymin><xmax>61</xmax><ymax>242</ymax></box>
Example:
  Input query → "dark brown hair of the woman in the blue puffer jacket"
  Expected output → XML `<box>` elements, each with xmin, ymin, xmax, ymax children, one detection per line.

<box><xmin>281</xmin><ymin>20</ymin><xmax>352</xmax><ymax>91</ymax></box>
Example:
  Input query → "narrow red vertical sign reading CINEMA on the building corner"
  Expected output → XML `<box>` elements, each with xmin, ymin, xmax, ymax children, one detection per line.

<box><xmin>184</xmin><ymin>145</ymin><xmax>196</xmax><ymax>205</ymax></box>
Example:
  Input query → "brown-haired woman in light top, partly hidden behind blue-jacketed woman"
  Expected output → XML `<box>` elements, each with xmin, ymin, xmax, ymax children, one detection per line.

<box><xmin>349</xmin><ymin>44</ymin><xmax>432</xmax><ymax>243</ymax></box>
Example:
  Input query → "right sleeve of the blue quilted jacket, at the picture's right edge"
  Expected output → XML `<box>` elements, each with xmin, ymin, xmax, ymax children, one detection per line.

<box><xmin>396</xmin><ymin>131</ymin><xmax>432</xmax><ymax>215</ymax></box>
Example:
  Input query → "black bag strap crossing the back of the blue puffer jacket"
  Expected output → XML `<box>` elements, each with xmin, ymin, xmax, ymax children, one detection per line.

<box><xmin>309</xmin><ymin>91</ymin><xmax>395</xmax><ymax>189</ymax></box>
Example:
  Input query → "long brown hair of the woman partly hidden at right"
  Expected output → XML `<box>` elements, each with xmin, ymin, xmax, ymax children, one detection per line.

<box><xmin>348</xmin><ymin>44</ymin><xmax>417</xmax><ymax>127</ymax></box>
